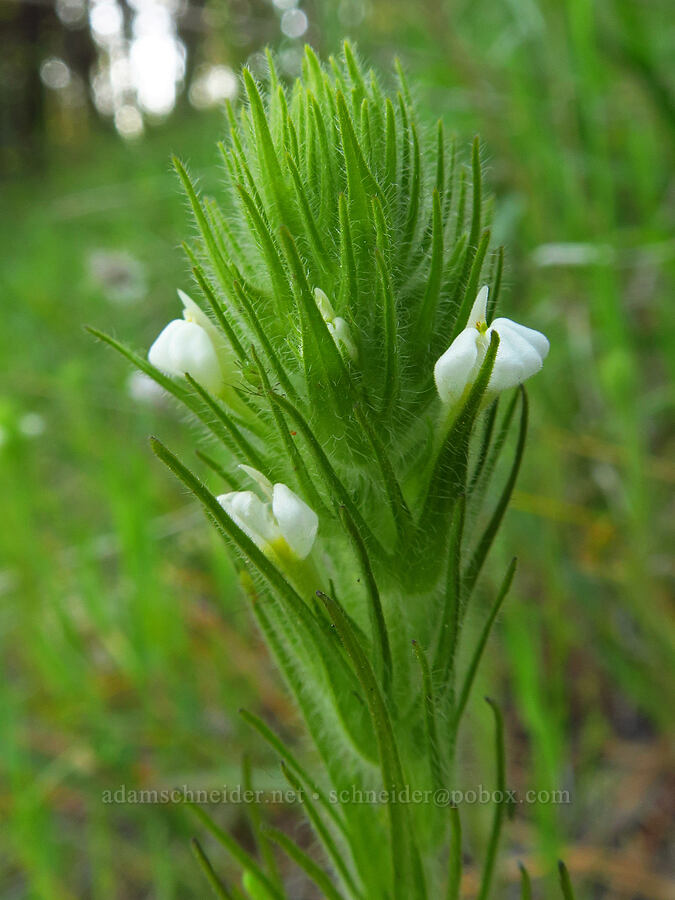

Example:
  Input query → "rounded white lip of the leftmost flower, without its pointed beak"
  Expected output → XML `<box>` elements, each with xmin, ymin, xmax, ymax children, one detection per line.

<box><xmin>148</xmin><ymin>319</ymin><xmax>222</xmax><ymax>392</ymax></box>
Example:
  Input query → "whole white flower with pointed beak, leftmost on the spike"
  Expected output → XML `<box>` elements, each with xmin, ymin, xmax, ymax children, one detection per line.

<box><xmin>148</xmin><ymin>291</ymin><xmax>231</xmax><ymax>394</ymax></box>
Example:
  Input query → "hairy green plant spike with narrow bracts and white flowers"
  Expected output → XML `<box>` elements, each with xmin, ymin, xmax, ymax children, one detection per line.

<box><xmin>90</xmin><ymin>44</ymin><xmax>572</xmax><ymax>900</ymax></box>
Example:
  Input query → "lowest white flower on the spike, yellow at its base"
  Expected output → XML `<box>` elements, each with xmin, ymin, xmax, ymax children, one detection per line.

<box><xmin>218</xmin><ymin>466</ymin><xmax>319</xmax><ymax>559</ymax></box>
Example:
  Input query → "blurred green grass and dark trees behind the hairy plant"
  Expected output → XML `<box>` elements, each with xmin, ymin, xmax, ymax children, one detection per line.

<box><xmin>0</xmin><ymin>0</ymin><xmax>675</xmax><ymax>900</ymax></box>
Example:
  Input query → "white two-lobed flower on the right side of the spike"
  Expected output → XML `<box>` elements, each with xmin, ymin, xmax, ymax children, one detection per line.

<box><xmin>434</xmin><ymin>285</ymin><xmax>549</xmax><ymax>404</ymax></box>
